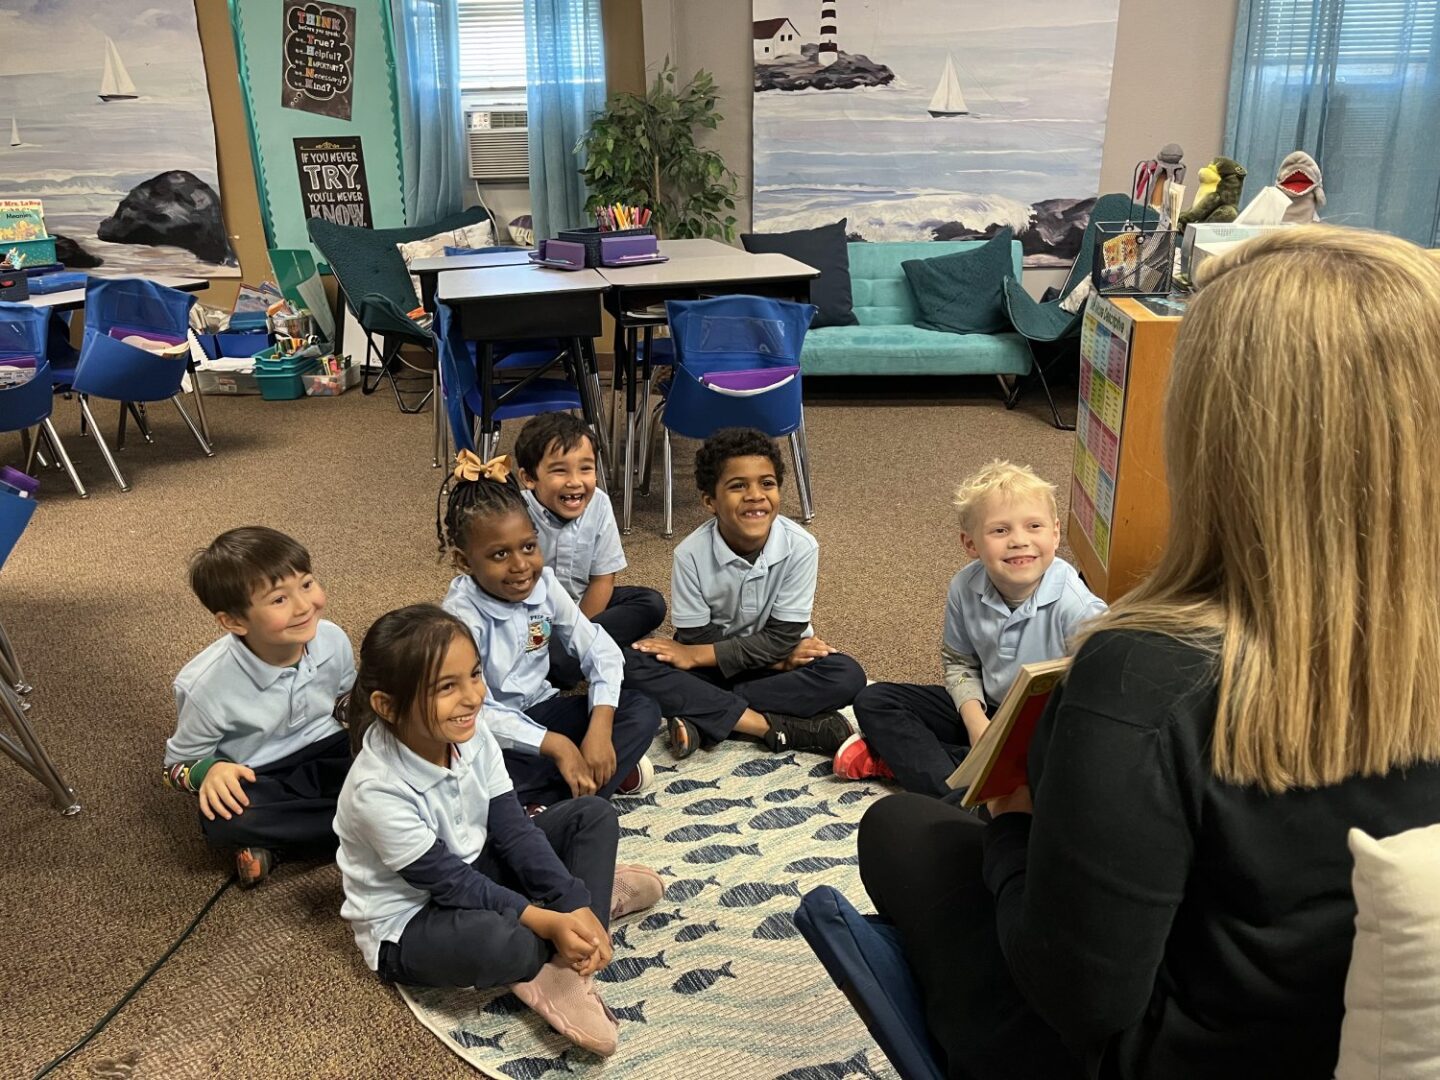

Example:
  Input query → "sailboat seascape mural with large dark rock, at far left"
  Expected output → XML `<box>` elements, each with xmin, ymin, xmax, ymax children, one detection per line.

<box><xmin>0</xmin><ymin>0</ymin><xmax>239</xmax><ymax>278</ymax></box>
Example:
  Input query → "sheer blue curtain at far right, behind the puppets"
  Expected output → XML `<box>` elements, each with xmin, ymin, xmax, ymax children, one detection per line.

<box><xmin>1225</xmin><ymin>0</ymin><xmax>1440</xmax><ymax>246</ymax></box>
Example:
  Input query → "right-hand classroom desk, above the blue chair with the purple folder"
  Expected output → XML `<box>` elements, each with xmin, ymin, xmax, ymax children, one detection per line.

<box><xmin>598</xmin><ymin>239</ymin><xmax>819</xmax><ymax>533</ymax></box>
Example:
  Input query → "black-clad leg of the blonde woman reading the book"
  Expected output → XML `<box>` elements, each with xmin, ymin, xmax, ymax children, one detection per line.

<box><xmin>857</xmin><ymin>793</ymin><xmax>1081</xmax><ymax>1080</ymax></box>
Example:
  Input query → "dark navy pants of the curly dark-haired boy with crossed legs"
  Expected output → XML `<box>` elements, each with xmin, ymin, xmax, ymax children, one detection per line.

<box><xmin>625</xmin><ymin>649</ymin><xmax>865</xmax><ymax>746</ymax></box>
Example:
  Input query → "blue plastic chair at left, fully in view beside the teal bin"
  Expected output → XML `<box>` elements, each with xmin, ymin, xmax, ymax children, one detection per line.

<box><xmin>71</xmin><ymin>278</ymin><xmax>215</xmax><ymax>491</ymax></box>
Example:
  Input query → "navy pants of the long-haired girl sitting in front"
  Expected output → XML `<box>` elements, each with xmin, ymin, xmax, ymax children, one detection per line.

<box><xmin>379</xmin><ymin>800</ymin><xmax>621</xmax><ymax>989</ymax></box>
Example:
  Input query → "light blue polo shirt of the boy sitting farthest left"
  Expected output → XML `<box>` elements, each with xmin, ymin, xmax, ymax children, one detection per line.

<box><xmin>166</xmin><ymin>619</ymin><xmax>356</xmax><ymax>769</ymax></box>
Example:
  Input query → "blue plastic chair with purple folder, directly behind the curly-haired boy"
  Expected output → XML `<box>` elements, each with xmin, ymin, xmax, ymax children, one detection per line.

<box><xmin>661</xmin><ymin>295</ymin><xmax>815</xmax><ymax>536</ymax></box>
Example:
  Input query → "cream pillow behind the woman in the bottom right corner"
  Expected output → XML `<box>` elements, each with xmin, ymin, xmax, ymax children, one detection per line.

<box><xmin>1335</xmin><ymin>825</ymin><xmax>1440</xmax><ymax>1080</ymax></box>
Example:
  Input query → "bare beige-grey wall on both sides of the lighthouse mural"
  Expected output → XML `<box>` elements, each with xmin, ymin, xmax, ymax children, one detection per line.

<box><xmin>642</xmin><ymin>0</ymin><xmax>1238</xmax><ymax>289</ymax></box>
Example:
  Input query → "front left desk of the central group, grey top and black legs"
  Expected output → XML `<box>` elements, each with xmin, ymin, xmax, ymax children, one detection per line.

<box><xmin>435</xmin><ymin>265</ymin><xmax>609</xmax><ymax>463</ymax></box>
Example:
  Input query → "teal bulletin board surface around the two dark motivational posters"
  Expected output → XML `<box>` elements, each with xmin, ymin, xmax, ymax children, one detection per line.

<box><xmin>229</xmin><ymin>0</ymin><xmax>405</xmax><ymax>259</ymax></box>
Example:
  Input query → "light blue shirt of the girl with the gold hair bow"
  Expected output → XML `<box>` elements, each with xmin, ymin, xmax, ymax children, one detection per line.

<box><xmin>442</xmin><ymin>566</ymin><xmax>625</xmax><ymax>753</ymax></box>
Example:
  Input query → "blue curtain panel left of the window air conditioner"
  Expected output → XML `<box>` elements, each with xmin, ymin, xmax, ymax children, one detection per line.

<box><xmin>390</xmin><ymin>0</ymin><xmax>465</xmax><ymax>225</ymax></box>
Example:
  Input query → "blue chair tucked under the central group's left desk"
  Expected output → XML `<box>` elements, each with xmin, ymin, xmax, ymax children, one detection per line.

<box><xmin>435</xmin><ymin>300</ymin><xmax>580</xmax><ymax>458</ymax></box>
